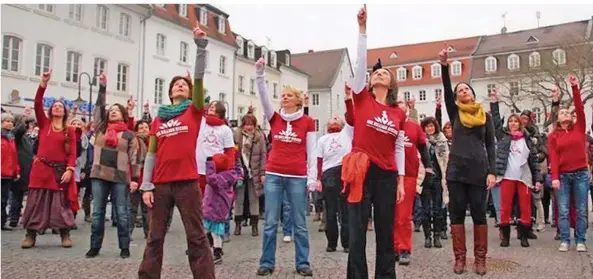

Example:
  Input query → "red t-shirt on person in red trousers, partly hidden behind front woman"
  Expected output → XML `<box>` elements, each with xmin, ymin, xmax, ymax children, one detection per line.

<box><xmin>404</xmin><ymin>120</ymin><xmax>426</xmax><ymax>178</ymax></box>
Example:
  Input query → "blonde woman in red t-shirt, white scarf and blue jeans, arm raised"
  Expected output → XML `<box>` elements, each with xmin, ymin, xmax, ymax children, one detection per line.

<box><xmin>255</xmin><ymin>55</ymin><xmax>317</xmax><ymax>276</ymax></box>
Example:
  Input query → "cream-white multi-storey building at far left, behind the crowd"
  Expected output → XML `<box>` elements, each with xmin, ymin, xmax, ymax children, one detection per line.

<box><xmin>2</xmin><ymin>4</ymin><xmax>150</xmax><ymax>118</ymax></box>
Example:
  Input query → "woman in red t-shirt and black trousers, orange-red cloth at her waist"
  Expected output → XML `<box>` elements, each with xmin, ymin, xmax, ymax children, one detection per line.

<box><xmin>342</xmin><ymin>5</ymin><xmax>406</xmax><ymax>279</ymax></box>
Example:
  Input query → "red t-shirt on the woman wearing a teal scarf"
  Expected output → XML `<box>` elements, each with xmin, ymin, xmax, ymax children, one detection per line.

<box><xmin>150</xmin><ymin>105</ymin><xmax>203</xmax><ymax>184</ymax></box>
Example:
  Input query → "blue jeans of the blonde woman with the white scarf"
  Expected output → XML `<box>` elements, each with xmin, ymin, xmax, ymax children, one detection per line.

<box><xmin>259</xmin><ymin>174</ymin><xmax>309</xmax><ymax>269</ymax></box>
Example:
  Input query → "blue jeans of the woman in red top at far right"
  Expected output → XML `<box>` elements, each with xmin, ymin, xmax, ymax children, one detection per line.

<box><xmin>554</xmin><ymin>170</ymin><xmax>589</xmax><ymax>244</ymax></box>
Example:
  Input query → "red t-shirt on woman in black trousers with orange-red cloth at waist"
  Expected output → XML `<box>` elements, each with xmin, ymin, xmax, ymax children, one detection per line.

<box><xmin>352</xmin><ymin>87</ymin><xmax>406</xmax><ymax>171</ymax></box>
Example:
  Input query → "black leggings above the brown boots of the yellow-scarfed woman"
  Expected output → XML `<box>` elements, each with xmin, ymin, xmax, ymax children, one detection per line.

<box><xmin>447</xmin><ymin>181</ymin><xmax>488</xmax><ymax>225</ymax></box>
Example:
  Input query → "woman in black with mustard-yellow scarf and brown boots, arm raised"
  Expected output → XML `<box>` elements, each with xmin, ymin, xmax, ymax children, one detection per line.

<box><xmin>439</xmin><ymin>50</ymin><xmax>496</xmax><ymax>275</ymax></box>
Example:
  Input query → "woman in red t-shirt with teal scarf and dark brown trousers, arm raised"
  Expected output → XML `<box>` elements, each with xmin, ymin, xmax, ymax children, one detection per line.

<box><xmin>138</xmin><ymin>22</ymin><xmax>215</xmax><ymax>279</ymax></box>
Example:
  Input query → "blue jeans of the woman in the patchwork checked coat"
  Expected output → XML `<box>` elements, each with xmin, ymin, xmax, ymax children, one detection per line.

<box><xmin>91</xmin><ymin>179</ymin><xmax>130</xmax><ymax>249</ymax></box>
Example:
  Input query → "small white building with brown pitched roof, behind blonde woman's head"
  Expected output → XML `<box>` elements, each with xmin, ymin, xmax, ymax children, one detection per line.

<box><xmin>291</xmin><ymin>48</ymin><xmax>354</xmax><ymax>135</ymax></box>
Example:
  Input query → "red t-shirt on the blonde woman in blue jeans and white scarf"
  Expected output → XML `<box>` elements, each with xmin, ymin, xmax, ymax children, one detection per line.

<box><xmin>266</xmin><ymin>112</ymin><xmax>315</xmax><ymax>177</ymax></box>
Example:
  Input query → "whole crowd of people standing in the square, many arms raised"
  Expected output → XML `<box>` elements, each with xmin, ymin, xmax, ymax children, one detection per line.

<box><xmin>1</xmin><ymin>6</ymin><xmax>591</xmax><ymax>278</ymax></box>
